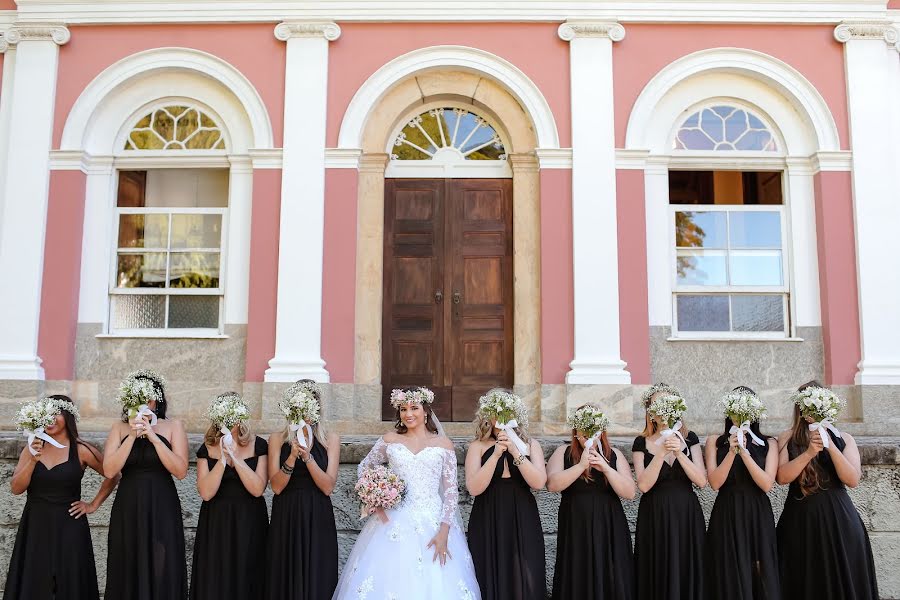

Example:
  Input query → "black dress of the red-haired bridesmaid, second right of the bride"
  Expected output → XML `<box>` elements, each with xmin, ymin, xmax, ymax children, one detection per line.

<box><xmin>553</xmin><ymin>446</ymin><xmax>634</xmax><ymax>600</ymax></box>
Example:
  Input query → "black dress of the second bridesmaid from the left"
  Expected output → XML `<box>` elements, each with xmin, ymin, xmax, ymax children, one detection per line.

<box><xmin>104</xmin><ymin>436</ymin><xmax>187</xmax><ymax>600</ymax></box>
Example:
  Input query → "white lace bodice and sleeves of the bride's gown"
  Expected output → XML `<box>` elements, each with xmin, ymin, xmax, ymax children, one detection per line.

<box><xmin>357</xmin><ymin>438</ymin><xmax>459</xmax><ymax>525</ymax></box>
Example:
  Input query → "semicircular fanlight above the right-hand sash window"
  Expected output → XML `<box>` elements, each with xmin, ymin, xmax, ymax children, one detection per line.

<box><xmin>673</xmin><ymin>105</ymin><xmax>778</xmax><ymax>152</ymax></box>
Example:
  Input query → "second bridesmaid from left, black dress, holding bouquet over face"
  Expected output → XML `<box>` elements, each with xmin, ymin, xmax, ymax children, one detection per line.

<box><xmin>103</xmin><ymin>369</ymin><xmax>188</xmax><ymax>600</ymax></box>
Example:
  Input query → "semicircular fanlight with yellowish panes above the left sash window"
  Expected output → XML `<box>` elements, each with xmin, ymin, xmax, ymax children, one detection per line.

<box><xmin>125</xmin><ymin>106</ymin><xmax>225</xmax><ymax>150</ymax></box>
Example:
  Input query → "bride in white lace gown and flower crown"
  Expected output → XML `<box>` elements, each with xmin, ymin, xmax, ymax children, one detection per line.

<box><xmin>334</xmin><ymin>387</ymin><xmax>481</xmax><ymax>600</ymax></box>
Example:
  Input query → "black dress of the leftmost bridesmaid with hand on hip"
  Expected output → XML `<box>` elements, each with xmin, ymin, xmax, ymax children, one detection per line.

<box><xmin>3</xmin><ymin>441</ymin><xmax>100</xmax><ymax>600</ymax></box>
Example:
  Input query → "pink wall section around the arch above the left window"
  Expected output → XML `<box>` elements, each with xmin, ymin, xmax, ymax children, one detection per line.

<box><xmin>53</xmin><ymin>23</ymin><xmax>285</xmax><ymax>148</ymax></box>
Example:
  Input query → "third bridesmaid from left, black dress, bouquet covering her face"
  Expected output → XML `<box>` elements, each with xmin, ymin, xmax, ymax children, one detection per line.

<box><xmin>191</xmin><ymin>392</ymin><xmax>269</xmax><ymax>600</ymax></box>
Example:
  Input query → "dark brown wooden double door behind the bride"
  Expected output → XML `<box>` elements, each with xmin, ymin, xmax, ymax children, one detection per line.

<box><xmin>381</xmin><ymin>179</ymin><xmax>513</xmax><ymax>421</ymax></box>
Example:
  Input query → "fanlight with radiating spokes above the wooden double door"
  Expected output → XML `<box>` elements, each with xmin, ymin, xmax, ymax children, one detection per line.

<box><xmin>391</xmin><ymin>108</ymin><xmax>506</xmax><ymax>160</ymax></box>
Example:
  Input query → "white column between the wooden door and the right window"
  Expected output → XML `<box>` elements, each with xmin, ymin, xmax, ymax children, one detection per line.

<box><xmin>559</xmin><ymin>22</ymin><xmax>631</xmax><ymax>384</ymax></box>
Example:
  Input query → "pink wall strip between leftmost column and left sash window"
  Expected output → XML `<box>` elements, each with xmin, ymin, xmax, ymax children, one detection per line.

<box><xmin>38</xmin><ymin>171</ymin><xmax>85</xmax><ymax>379</ymax></box>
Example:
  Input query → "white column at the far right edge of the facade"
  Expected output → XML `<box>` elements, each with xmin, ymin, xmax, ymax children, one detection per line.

<box><xmin>826</xmin><ymin>22</ymin><xmax>900</xmax><ymax>385</ymax></box>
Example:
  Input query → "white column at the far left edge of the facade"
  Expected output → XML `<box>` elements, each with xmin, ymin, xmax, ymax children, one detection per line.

<box><xmin>0</xmin><ymin>25</ymin><xmax>69</xmax><ymax>380</ymax></box>
